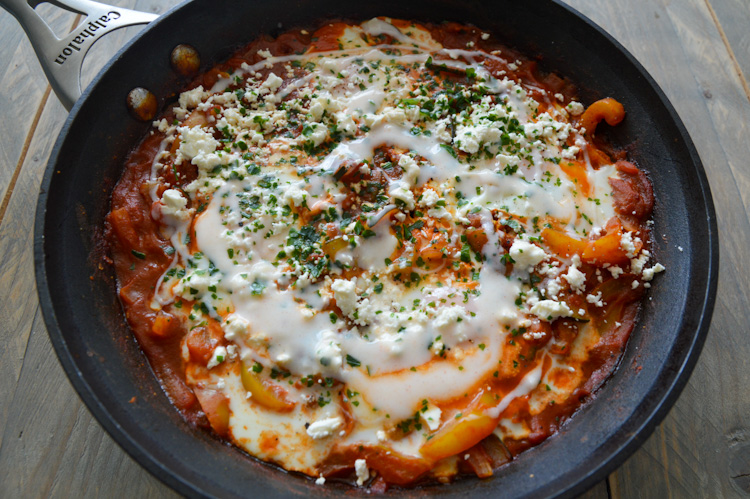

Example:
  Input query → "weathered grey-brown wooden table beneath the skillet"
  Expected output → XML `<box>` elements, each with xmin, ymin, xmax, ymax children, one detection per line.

<box><xmin>0</xmin><ymin>0</ymin><xmax>750</xmax><ymax>498</ymax></box>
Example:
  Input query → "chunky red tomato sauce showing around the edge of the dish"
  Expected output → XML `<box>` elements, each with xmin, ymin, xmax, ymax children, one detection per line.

<box><xmin>107</xmin><ymin>18</ymin><xmax>654</xmax><ymax>490</ymax></box>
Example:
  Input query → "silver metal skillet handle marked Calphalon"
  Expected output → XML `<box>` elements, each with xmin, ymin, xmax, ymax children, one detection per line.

<box><xmin>0</xmin><ymin>0</ymin><xmax>159</xmax><ymax>110</ymax></box>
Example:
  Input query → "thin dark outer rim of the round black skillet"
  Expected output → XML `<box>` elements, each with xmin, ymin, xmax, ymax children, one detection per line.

<box><xmin>34</xmin><ymin>0</ymin><xmax>719</xmax><ymax>497</ymax></box>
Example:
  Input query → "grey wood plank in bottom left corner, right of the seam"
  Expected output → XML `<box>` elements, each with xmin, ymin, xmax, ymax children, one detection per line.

<box><xmin>0</xmin><ymin>309</ymin><xmax>177</xmax><ymax>497</ymax></box>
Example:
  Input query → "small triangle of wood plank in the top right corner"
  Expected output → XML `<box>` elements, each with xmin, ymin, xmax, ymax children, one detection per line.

<box><xmin>707</xmin><ymin>0</ymin><xmax>750</xmax><ymax>99</ymax></box>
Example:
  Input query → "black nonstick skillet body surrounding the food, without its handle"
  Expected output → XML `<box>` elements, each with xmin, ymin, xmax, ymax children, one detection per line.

<box><xmin>16</xmin><ymin>0</ymin><xmax>718</xmax><ymax>497</ymax></box>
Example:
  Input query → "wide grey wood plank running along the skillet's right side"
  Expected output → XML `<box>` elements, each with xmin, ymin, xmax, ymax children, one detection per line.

<box><xmin>571</xmin><ymin>0</ymin><xmax>750</xmax><ymax>498</ymax></box>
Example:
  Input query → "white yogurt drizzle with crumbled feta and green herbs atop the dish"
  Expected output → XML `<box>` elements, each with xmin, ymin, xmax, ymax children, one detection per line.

<box><xmin>151</xmin><ymin>19</ymin><xmax>628</xmax><ymax>472</ymax></box>
